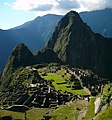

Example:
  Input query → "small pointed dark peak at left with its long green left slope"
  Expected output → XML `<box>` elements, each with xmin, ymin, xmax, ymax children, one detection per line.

<box><xmin>1</xmin><ymin>44</ymin><xmax>34</xmax><ymax>88</ymax></box>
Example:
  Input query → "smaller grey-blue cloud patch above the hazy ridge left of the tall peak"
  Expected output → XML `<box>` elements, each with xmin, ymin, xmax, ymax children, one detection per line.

<box><xmin>32</xmin><ymin>4</ymin><xmax>53</xmax><ymax>11</ymax></box>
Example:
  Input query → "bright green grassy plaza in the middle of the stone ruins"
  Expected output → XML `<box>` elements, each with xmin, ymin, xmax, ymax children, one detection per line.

<box><xmin>40</xmin><ymin>69</ymin><xmax>88</xmax><ymax>95</ymax></box>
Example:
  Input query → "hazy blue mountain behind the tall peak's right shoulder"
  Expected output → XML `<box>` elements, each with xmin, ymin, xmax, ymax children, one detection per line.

<box><xmin>80</xmin><ymin>8</ymin><xmax>112</xmax><ymax>37</ymax></box>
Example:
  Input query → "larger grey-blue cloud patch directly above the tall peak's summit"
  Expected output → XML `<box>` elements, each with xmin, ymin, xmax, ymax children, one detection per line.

<box><xmin>57</xmin><ymin>0</ymin><xmax>80</xmax><ymax>10</ymax></box>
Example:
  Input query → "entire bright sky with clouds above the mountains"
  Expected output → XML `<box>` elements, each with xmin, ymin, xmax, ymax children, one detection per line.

<box><xmin>0</xmin><ymin>0</ymin><xmax>112</xmax><ymax>30</ymax></box>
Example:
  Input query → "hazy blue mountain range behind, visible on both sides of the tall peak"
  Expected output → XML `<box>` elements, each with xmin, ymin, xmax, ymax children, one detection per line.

<box><xmin>0</xmin><ymin>9</ymin><xmax>112</xmax><ymax>70</ymax></box>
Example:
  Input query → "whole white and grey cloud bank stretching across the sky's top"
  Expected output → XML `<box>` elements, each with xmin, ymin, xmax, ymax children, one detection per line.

<box><xmin>5</xmin><ymin>0</ymin><xmax>112</xmax><ymax>15</ymax></box>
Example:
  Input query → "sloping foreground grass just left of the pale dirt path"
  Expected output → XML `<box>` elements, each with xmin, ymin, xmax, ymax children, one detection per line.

<box><xmin>50</xmin><ymin>101</ymin><xmax>85</xmax><ymax>120</ymax></box>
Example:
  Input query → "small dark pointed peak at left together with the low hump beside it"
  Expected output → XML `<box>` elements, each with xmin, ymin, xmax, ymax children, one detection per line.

<box><xmin>1</xmin><ymin>43</ymin><xmax>61</xmax><ymax>89</ymax></box>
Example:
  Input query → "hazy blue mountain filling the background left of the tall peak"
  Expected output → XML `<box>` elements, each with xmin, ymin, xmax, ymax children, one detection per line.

<box><xmin>0</xmin><ymin>14</ymin><xmax>61</xmax><ymax>70</ymax></box>
